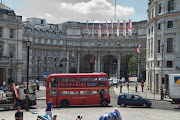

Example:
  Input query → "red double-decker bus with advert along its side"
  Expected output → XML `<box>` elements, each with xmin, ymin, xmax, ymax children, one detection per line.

<box><xmin>46</xmin><ymin>73</ymin><xmax>110</xmax><ymax>107</ymax></box>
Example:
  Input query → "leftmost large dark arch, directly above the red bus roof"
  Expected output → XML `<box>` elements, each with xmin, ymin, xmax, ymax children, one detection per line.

<box><xmin>80</xmin><ymin>55</ymin><xmax>96</xmax><ymax>73</ymax></box>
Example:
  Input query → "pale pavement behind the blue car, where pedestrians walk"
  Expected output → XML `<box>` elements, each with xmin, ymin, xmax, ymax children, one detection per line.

<box><xmin>114</xmin><ymin>83</ymin><xmax>172</xmax><ymax>101</ymax></box>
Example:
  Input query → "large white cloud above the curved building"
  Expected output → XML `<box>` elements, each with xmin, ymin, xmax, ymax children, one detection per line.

<box><xmin>15</xmin><ymin>0</ymin><xmax>135</xmax><ymax>23</ymax></box>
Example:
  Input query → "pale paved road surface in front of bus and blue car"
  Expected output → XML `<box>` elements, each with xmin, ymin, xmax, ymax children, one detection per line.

<box><xmin>0</xmin><ymin>84</ymin><xmax>180</xmax><ymax>120</ymax></box>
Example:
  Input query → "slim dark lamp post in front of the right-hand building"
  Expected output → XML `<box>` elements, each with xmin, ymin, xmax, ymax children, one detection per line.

<box><xmin>161</xmin><ymin>43</ymin><xmax>164</xmax><ymax>100</ymax></box>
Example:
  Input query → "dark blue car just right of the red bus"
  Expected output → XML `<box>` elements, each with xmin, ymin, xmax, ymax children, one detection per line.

<box><xmin>117</xmin><ymin>94</ymin><xmax>152</xmax><ymax>107</ymax></box>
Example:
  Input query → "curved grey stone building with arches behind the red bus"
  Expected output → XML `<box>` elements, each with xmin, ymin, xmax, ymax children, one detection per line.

<box><xmin>23</xmin><ymin>18</ymin><xmax>146</xmax><ymax>82</ymax></box>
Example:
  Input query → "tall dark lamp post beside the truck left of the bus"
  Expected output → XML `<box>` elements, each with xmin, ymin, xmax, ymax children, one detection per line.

<box><xmin>26</xmin><ymin>40</ymin><xmax>31</xmax><ymax>111</ymax></box>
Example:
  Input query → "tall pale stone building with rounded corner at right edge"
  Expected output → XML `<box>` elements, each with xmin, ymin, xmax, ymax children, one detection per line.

<box><xmin>146</xmin><ymin>0</ymin><xmax>180</xmax><ymax>92</ymax></box>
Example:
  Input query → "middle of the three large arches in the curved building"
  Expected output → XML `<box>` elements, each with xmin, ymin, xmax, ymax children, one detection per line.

<box><xmin>101</xmin><ymin>55</ymin><xmax>117</xmax><ymax>78</ymax></box>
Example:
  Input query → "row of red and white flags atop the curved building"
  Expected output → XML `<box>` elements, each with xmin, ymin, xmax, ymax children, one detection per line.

<box><xmin>87</xmin><ymin>20</ymin><xmax>132</xmax><ymax>37</ymax></box>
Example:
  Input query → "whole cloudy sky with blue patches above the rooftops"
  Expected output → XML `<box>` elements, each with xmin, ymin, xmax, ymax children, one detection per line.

<box><xmin>3</xmin><ymin>0</ymin><xmax>148</xmax><ymax>23</ymax></box>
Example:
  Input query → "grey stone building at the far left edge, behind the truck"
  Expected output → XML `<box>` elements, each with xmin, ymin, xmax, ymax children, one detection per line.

<box><xmin>0</xmin><ymin>4</ymin><xmax>23</xmax><ymax>86</ymax></box>
